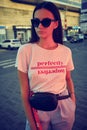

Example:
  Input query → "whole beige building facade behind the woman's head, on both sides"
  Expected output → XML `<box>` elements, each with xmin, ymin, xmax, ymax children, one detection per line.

<box><xmin>0</xmin><ymin>0</ymin><xmax>81</xmax><ymax>42</ymax></box>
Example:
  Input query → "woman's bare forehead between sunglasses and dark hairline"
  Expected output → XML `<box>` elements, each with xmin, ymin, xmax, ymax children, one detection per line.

<box><xmin>34</xmin><ymin>9</ymin><xmax>54</xmax><ymax>19</ymax></box>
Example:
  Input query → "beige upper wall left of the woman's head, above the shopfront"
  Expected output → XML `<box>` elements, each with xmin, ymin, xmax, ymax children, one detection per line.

<box><xmin>0</xmin><ymin>0</ymin><xmax>34</xmax><ymax>28</ymax></box>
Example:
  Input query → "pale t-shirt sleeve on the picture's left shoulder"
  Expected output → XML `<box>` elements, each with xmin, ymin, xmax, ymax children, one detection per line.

<box><xmin>15</xmin><ymin>44</ymin><xmax>31</xmax><ymax>73</ymax></box>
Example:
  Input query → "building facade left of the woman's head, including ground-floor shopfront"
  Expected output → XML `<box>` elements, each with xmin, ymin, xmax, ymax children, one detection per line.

<box><xmin>0</xmin><ymin>0</ymin><xmax>34</xmax><ymax>42</ymax></box>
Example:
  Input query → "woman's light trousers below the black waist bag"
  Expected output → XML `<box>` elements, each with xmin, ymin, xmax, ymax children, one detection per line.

<box><xmin>25</xmin><ymin>90</ymin><xmax>76</xmax><ymax>130</ymax></box>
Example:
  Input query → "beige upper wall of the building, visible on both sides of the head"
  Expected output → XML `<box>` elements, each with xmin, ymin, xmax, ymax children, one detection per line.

<box><xmin>0</xmin><ymin>0</ymin><xmax>79</xmax><ymax>28</ymax></box>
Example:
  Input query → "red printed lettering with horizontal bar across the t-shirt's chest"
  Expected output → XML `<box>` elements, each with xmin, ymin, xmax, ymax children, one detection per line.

<box><xmin>31</xmin><ymin>61</ymin><xmax>66</xmax><ymax>75</ymax></box>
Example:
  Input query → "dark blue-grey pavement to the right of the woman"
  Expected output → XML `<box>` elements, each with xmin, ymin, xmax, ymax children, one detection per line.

<box><xmin>70</xmin><ymin>40</ymin><xmax>87</xmax><ymax>130</ymax></box>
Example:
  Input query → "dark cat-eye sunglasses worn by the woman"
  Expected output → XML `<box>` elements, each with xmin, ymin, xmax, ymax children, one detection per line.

<box><xmin>31</xmin><ymin>18</ymin><xmax>56</xmax><ymax>28</ymax></box>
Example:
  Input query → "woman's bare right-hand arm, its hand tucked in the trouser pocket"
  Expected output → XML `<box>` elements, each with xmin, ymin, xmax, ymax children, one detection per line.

<box><xmin>66</xmin><ymin>71</ymin><xmax>76</xmax><ymax>103</ymax></box>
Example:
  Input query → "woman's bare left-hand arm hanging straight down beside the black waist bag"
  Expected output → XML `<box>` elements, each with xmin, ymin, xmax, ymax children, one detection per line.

<box><xmin>18</xmin><ymin>70</ymin><xmax>37</xmax><ymax>130</ymax></box>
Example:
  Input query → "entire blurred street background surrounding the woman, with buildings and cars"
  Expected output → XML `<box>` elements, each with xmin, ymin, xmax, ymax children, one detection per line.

<box><xmin>0</xmin><ymin>0</ymin><xmax>87</xmax><ymax>130</ymax></box>
